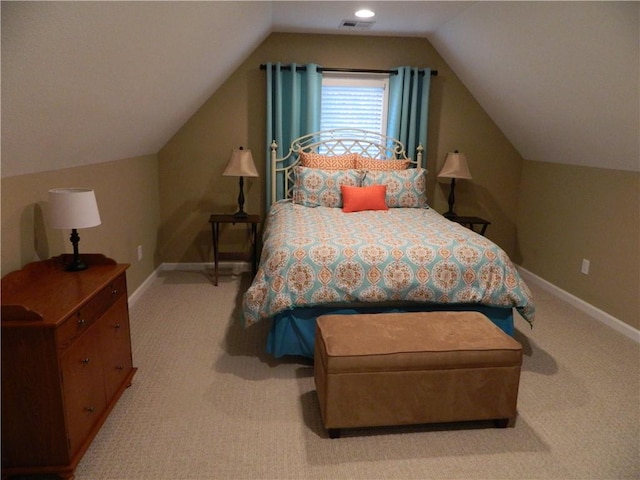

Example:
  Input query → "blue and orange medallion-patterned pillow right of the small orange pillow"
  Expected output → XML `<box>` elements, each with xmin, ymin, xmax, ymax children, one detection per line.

<box><xmin>362</xmin><ymin>168</ymin><xmax>427</xmax><ymax>208</ymax></box>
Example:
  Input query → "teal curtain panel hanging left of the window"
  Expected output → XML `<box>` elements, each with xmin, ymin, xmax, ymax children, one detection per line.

<box><xmin>265</xmin><ymin>63</ymin><xmax>322</xmax><ymax>207</ymax></box>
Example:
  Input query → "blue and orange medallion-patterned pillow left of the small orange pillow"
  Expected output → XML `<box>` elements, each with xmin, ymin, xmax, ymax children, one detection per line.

<box><xmin>293</xmin><ymin>165</ymin><xmax>362</xmax><ymax>208</ymax></box>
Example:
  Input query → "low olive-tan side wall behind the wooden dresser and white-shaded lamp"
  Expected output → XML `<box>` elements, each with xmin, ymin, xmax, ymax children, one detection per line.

<box><xmin>2</xmin><ymin>155</ymin><xmax>160</xmax><ymax>294</ymax></box>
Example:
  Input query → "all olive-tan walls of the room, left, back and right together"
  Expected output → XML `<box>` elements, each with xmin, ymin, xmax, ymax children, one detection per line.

<box><xmin>1</xmin><ymin>30</ymin><xmax>640</xmax><ymax>328</ymax></box>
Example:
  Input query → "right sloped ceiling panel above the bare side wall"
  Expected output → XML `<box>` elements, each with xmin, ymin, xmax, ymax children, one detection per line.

<box><xmin>429</xmin><ymin>2</ymin><xmax>640</xmax><ymax>171</ymax></box>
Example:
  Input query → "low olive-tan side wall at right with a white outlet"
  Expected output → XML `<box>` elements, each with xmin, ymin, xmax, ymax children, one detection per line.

<box><xmin>517</xmin><ymin>161</ymin><xmax>640</xmax><ymax>328</ymax></box>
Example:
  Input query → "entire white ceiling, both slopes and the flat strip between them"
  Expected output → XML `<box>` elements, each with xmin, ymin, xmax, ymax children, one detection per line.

<box><xmin>1</xmin><ymin>1</ymin><xmax>640</xmax><ymax>177</ymax></box>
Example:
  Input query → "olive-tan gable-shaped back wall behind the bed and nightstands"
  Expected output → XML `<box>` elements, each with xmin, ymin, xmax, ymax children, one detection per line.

<box><xmin>158</xmin><ymin>34</ymin><xmax>522</xmax><ymax>262</ymax></box>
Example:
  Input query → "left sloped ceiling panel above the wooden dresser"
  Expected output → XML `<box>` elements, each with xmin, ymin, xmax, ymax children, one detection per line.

<box><xmin>1</xmin><ymin>1</ymin><xmax>271</xmax><ymax>177</ymax></box>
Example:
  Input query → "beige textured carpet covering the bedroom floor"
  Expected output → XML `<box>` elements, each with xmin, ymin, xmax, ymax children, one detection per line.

<box><xmin>76</xmin><ymin>271</ymin><xmax>640</xmax><ymax>480</ymax></box>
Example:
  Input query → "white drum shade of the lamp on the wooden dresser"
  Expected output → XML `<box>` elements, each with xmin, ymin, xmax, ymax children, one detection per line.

<box><xmin>49</xmin><ymin>188</ymin><xmax>101</xmax><ymax>229</ymax></box>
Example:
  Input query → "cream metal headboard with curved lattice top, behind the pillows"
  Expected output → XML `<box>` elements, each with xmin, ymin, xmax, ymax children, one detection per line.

<box><xmin>271</xmin><ymin>128</ymin><xmax>424</xmax><ymax>203</ymax></box>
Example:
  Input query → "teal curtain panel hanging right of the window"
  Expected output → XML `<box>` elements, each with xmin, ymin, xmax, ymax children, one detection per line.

<box><xmin>387</xmin><ymin>67</ymin><xmax>431</xmax><ymax>168</ymax></box>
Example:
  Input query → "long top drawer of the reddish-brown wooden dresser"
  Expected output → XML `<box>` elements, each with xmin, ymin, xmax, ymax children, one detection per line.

<box><xmin>56</xmin><ymin>274</ymin><xmax>127</xmax><ymax>351</ymax></box>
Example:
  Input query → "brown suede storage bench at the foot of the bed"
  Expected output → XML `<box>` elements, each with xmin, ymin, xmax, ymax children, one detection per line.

<box><xmin>314</xmin><ymin>312</ymin><xmax>522</xmax><ymax>438</ymax></box>
